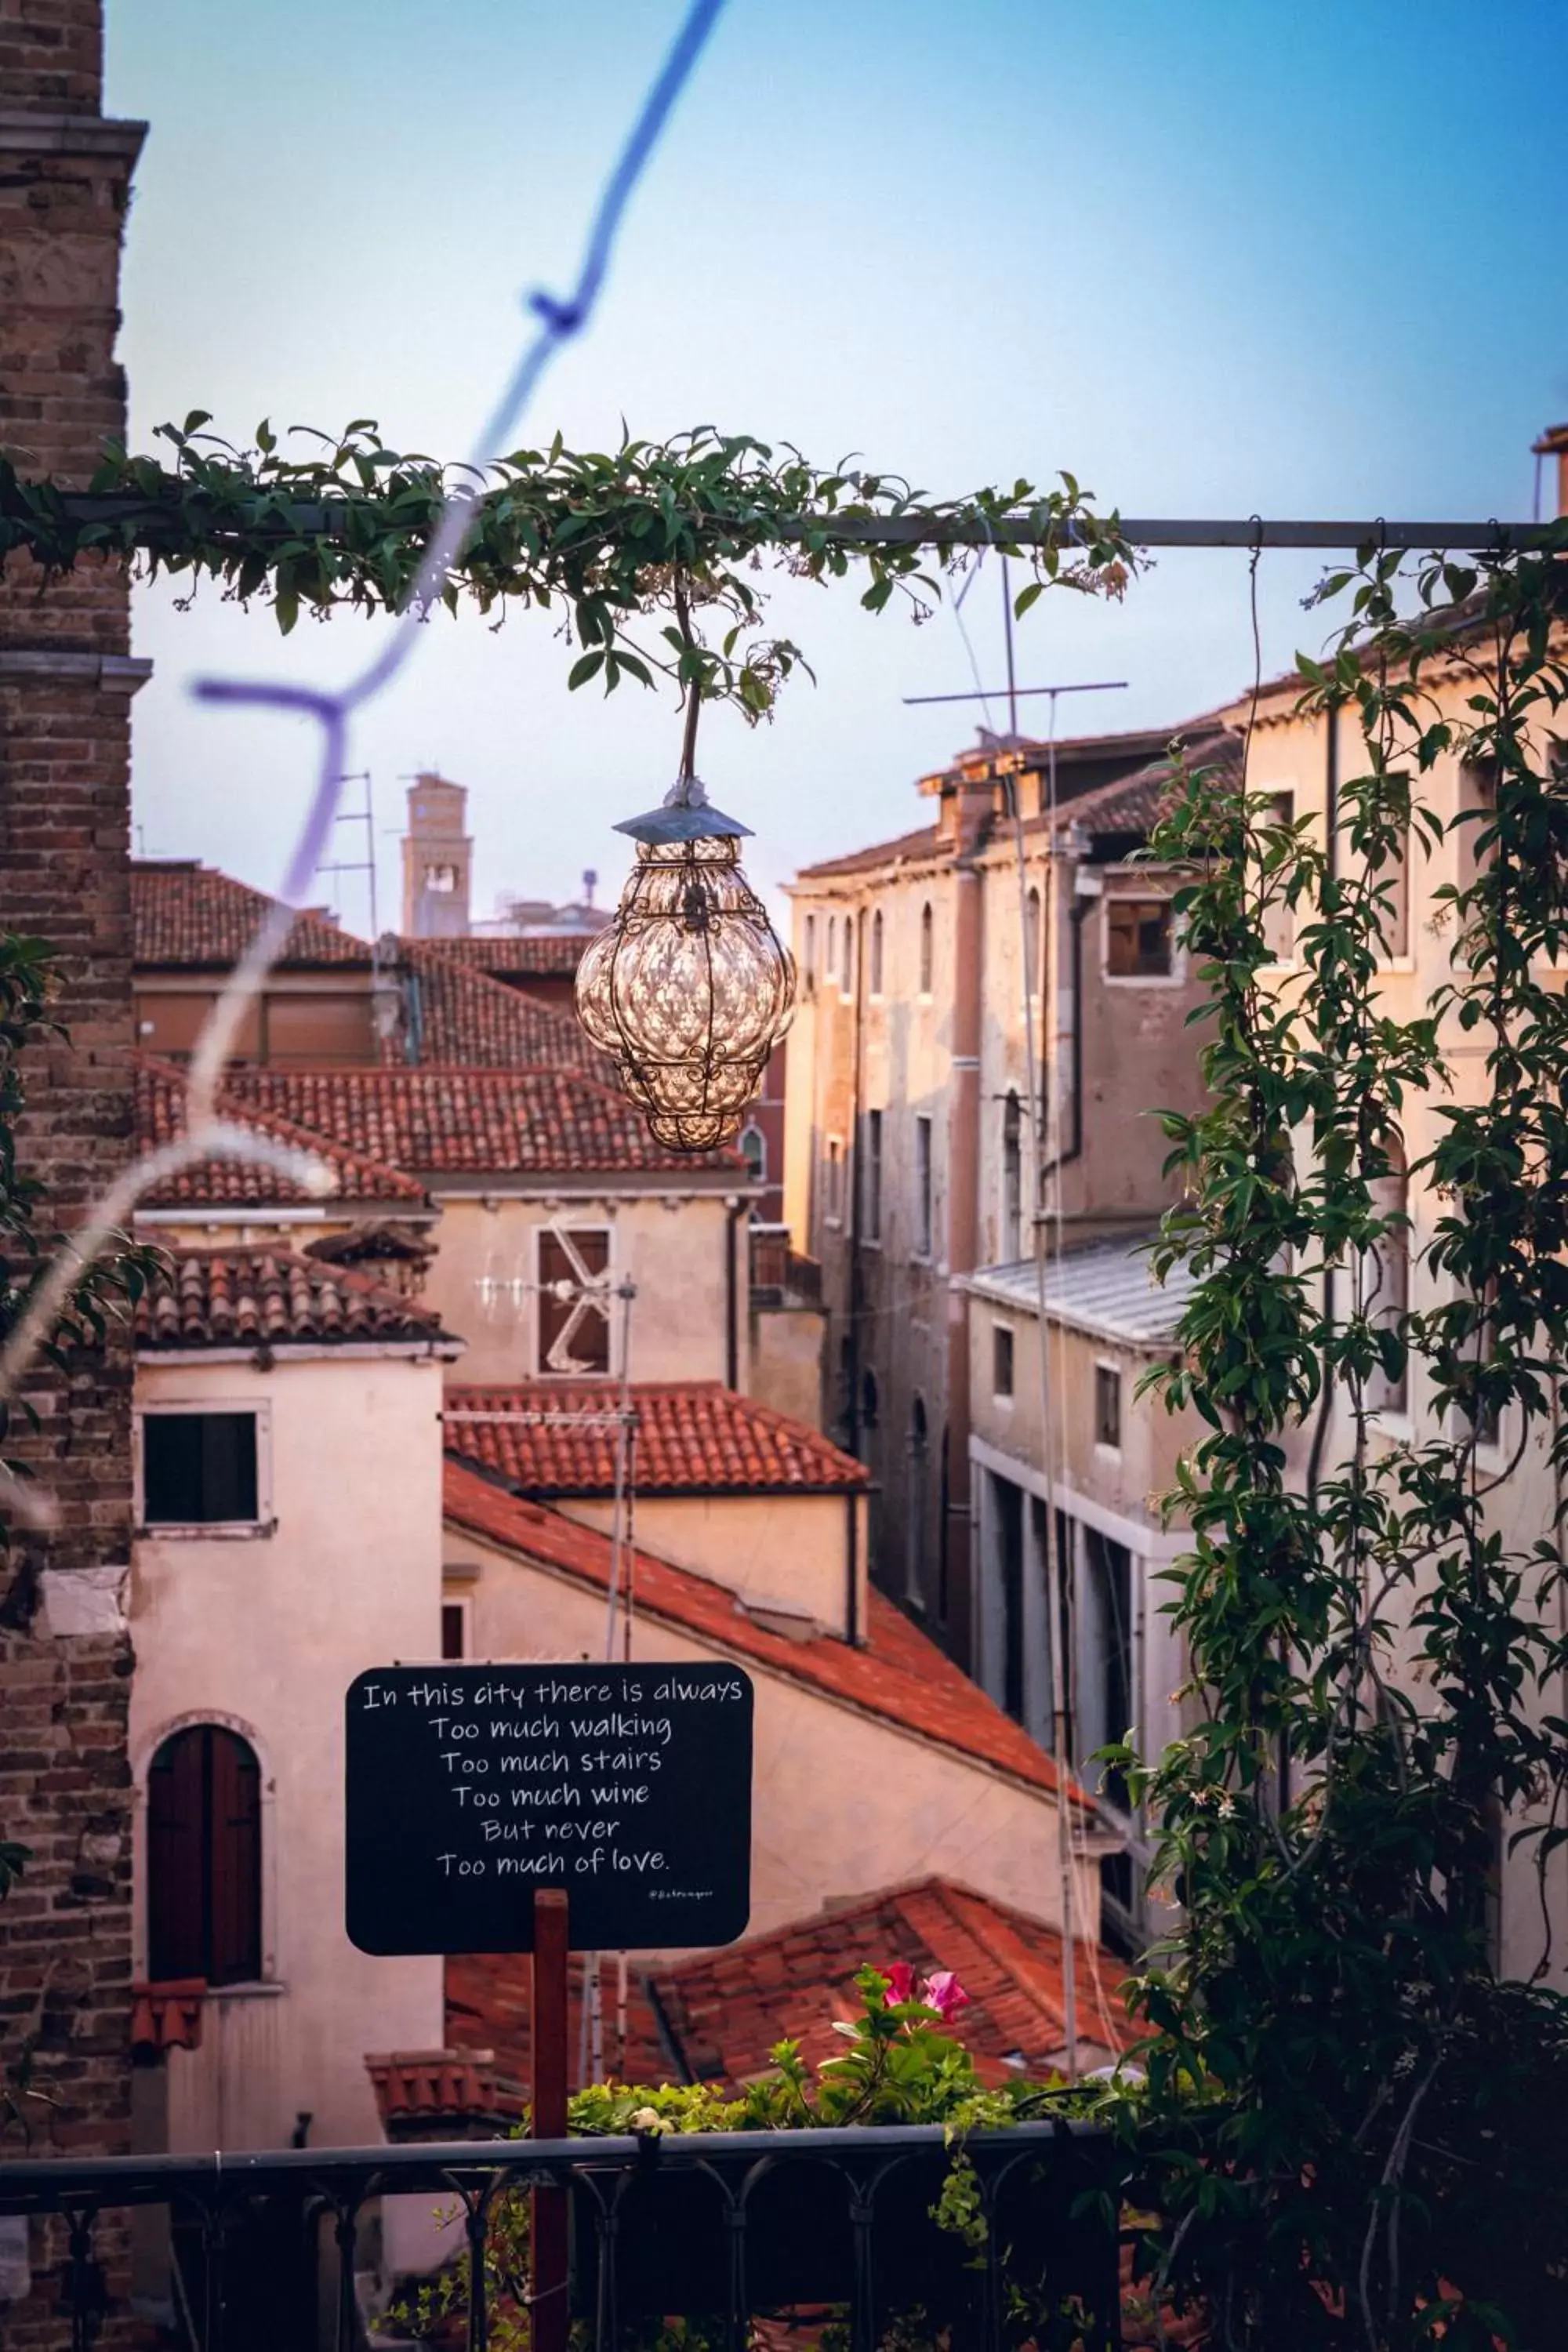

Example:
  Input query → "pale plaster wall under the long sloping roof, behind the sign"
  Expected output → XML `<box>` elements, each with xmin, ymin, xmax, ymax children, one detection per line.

<box><xmin>447</xmin><ymin>1526</ymin><xmax>1100</xmax><ymax>1959</ymax></box>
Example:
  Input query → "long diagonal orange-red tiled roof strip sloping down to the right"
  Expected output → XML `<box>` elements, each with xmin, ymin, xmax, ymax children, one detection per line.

<box><xmin>434</xmin><ymin>1458</ymin><xmax>1088</xmax><ymax>1809</ymax></box>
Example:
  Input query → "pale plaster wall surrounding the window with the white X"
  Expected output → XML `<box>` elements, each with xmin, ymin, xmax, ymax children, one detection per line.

<box><xmin>421</xmin><ymin>1190</ymin><xmax>750</xmax><ymax>1390</ymax></box>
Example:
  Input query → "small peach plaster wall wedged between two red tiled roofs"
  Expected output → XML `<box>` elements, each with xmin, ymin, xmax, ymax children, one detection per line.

<box><xmin>553</xmin><ymin>1494</ymin><xmax>867</xmax><ymax>1635</ymax></box>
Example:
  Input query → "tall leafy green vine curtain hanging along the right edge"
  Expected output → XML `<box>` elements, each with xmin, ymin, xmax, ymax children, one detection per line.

<box><xmin>1126</xmin><ymin>532</ymin><xmax>1568</xmax><ymax>2352</ymax></box>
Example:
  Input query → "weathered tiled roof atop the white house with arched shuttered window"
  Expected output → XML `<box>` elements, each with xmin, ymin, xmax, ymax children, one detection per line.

<box><xmin>136</xmin><ymin>1249</ymin><xmax>452</xmax><ymax>1355</ymax></box>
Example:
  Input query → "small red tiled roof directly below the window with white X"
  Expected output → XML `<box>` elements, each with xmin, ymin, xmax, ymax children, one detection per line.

<box><xmin>445</xmin><ymin>1381</ymin><xmax>867</xmax><ymax>1496</ymax></box>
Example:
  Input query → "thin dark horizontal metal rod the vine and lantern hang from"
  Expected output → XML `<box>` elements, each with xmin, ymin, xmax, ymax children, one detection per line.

<box><xmin>45</xmin><ymin>489</ymin><xmax>1556</xmax><ymax>555</ymax></box>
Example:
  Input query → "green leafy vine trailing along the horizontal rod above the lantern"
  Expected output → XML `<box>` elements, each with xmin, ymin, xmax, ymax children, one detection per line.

<box><xmin>0</xmin><ymin>423</ymin><xmax>1135</xmax><ymax>720</ymax></box>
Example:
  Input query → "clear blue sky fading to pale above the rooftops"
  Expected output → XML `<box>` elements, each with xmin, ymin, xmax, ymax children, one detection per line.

<box><xmin>106</xmin><ymin>0</ymin><xmax>1568</xmax><ymax>927</ymax></box>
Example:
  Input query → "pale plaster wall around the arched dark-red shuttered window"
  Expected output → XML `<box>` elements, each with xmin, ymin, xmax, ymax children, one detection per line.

<box><xmin>129</xmin><ymin>1352</ymin><xmax>442</xmax><ymax>2152</ymax></box>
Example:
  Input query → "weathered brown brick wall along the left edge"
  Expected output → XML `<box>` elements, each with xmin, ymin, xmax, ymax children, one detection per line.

<box><xmin>0</xmin><ymin>0</ymin><xmax>146</xmax><ymax>2352</ymax></box>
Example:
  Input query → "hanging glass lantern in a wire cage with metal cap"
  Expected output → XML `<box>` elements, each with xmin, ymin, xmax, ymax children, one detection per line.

<box><xmin>576</xmin><ymin>767</ymin><xmax>794</xmax><ymax>1152</ymax></box>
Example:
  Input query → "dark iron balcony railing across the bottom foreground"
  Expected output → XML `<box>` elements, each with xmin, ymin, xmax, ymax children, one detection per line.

<box><xmin>0</xmin><ymin>2122</ymin><xmax>1126</xmax><ymax>2352</ymax></box>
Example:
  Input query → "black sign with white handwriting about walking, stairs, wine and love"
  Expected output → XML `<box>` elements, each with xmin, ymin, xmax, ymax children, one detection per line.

<box><xmin>348</xmin><ymin>1665</ymin><xmax>753</xmax><ymax>1955</ymax></box>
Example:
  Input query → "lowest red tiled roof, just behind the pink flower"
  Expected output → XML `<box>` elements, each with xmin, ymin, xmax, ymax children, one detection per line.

<box><xmin>652</xmin><ymin>1877</ymin><xmax>1131</xmax><ymax>2091</ymax></box>
